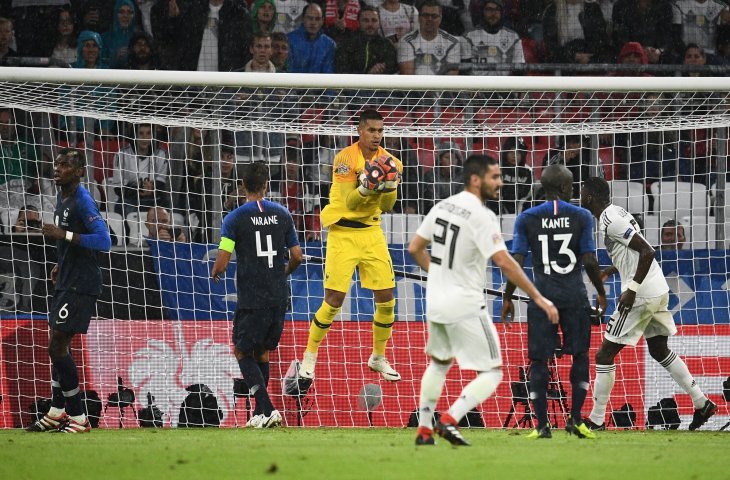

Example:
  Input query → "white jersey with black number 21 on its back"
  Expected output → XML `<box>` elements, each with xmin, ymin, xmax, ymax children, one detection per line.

<box><xmin>416</xmin><ymin>192</ymin><xmax>507</xmax><ymax>323</ymax></box>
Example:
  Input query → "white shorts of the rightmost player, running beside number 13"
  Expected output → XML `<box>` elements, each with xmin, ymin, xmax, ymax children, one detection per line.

<box><xmin>604</xmin><ymin>293</ymin><xmax>677</xmax><ymax>345</ymax></box>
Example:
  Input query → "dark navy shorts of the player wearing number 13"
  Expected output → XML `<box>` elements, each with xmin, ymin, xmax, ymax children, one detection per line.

<box><xmin>527</xmin><ymin>298</ymin><xmax>591</xmax><ymax>360</ymax></box>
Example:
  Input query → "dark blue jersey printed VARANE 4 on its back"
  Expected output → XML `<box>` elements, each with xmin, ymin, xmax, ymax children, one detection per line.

<box><xmin>221</xmin><ymin>200</ymin><xmax>299</xmax><ymax>309</ymax></box>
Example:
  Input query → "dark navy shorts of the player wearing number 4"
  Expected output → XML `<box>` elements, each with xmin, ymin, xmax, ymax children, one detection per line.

<box><xmin>233</xmin><ymin>305</ymin><xmax>286</xmax><ymax>353</ymax></box>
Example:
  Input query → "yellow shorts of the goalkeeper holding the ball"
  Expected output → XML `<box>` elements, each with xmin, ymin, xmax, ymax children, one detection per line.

<box><xmin>324</xmin><ymin>225</ymin><xmax>395</xmax><ymax>292</ymax></box>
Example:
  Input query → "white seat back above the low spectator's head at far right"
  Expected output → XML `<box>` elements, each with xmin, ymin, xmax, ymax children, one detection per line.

<box><xmin>651</xmin><ymin>182</ymin><xmax>708</xmax><ymax>219</ymax></box>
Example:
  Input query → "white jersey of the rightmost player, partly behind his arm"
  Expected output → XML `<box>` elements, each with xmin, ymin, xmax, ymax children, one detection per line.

<box><xmin>599</xmin><ymin>205</ymin><xmax>669</xmax><ymax>298</ymax></box>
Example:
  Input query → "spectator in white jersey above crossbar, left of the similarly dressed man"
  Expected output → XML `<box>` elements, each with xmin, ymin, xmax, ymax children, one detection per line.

<box><xmin>398</xmin><ymin>0</ymin><xmax>461</xmax><ymax>75</ymax></box>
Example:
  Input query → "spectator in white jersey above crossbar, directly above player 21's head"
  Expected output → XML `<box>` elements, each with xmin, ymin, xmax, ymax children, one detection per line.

<box><xmin>461</xmin><ymin>0</ymin><xmax>525</xmax><ymax>75</ymax></box>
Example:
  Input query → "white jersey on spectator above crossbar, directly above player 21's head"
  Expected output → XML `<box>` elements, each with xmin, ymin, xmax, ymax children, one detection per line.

<box><xmin>461</xmin><ymin>28</ymin><xmax>525</xmax><ymax>75</ymax></box>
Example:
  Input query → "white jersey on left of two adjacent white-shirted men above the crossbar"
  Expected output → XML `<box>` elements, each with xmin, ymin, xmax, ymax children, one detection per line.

<box><xmin>398</xmin><ymin>30</ymin><xmax>461</xmax><ymax>75</ymax></box>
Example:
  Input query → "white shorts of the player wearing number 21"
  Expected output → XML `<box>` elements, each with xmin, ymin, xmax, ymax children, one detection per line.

<box><xmin>426</xmin><ymin>309</ymin><xmax>502</xmax><ymax>372</ymax></box>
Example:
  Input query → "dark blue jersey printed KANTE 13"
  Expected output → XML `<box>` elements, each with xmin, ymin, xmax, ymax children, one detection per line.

<box><xmin>512</xmin><ymin>200</ymin><xmax>596</xmax><ymax>304</ymax></box>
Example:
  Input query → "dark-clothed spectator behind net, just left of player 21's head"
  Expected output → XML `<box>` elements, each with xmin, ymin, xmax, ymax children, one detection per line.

<box><xmin>421</xmin><ymin>142</ymin><xmax>464</xmax><ymax>214</ymax></box>
